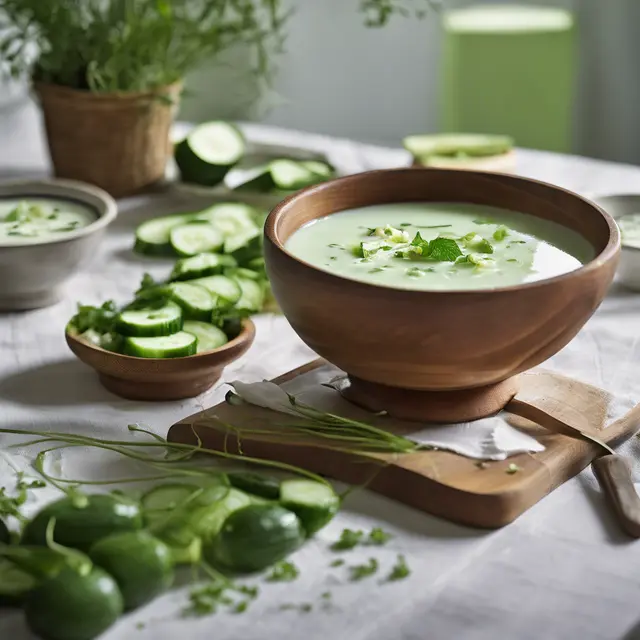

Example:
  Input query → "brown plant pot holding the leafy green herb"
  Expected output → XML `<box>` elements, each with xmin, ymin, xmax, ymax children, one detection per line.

<box><xmin>34</xmin><ymin>83</ymin><xmax>182</xmax><ymax>198</ymax></box>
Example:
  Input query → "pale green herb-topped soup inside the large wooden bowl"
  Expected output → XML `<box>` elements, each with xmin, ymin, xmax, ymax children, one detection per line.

<box><xmin>286</xmin><ymin>203</ymin><xmax>594</xmax><ymax>290</ymax></box>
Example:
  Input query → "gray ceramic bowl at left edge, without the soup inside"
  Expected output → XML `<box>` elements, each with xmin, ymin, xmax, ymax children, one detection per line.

<box><xmin>0</xmin><ymin>180</ymin><xmax>117</xmax><ymax>311</ymax></box>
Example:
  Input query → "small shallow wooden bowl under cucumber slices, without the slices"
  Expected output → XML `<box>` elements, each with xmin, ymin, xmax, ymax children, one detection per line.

<box><xmin>65</xmin><ymin>319</ymin><xmax>256</xmax><ymax>401</ymax></box>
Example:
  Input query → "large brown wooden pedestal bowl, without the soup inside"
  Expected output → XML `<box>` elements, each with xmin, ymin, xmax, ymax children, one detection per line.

<box><xmin>265</xmin><ymin>168</ymin><xmax>620</xmax><ymax>422</ymax></box>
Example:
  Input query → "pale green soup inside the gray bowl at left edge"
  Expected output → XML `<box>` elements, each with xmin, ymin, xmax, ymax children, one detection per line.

<box><xmin>0</xmin><ymin>198</ymin><xmax>98</xmax><ymax>245</ymax></box>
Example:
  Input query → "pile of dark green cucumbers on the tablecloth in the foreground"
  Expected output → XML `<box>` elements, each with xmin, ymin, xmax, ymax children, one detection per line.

<box><xmin>0</xmin><ymin>472</ymin><xmax>340</xmax><ymax>640</ymax></box>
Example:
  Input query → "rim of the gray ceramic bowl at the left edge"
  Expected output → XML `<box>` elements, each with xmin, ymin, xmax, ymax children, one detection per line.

<box><xmin>0</xmin><ymin>178</ymin><xmax>118</xmax><ymax>251</ymax></box>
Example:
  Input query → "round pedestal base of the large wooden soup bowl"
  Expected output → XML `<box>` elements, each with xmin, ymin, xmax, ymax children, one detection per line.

<box><xmin>337</xmin><ymin>376</ymin><xmax>519</xmax><ymax>423</ymax></box>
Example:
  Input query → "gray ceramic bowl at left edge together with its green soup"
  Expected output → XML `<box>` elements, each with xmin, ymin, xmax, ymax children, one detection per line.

<box><xmin>0</xmin><ymin>180</ymin><xmax>117</xmax><ymax>311</ymax></box>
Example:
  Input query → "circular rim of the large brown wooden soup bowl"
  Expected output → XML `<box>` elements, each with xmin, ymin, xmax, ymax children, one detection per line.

<box><xmin>264</xmin><ymin>167</ymin><xmax>621</xmax><ymax>297</ymax></box>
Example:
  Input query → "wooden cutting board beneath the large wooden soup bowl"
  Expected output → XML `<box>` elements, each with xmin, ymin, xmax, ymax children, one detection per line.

<box><xmin>168</xmin><ymin>360</ymin><xmax>640</xmax><ymax>529</ymax></box>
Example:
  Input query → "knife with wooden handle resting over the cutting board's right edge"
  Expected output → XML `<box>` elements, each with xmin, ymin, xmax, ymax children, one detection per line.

<box><xmin>505</xmin><ymin>398</ymin><xmax>640</xmax><ymax>538</ymax></box>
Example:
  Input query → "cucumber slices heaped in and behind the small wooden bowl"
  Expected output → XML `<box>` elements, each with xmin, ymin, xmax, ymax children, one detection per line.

<box><xmin>67</xmin><ymin>202</ymin><xmax>269</xmax><ymax>358</ymax></box>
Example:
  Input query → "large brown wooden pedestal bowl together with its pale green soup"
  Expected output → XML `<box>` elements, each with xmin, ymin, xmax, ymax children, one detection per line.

<box><xmin>265</xmin><ymin>168</ymin><xmax>620</xmax><ymax>421</ymax></box>
